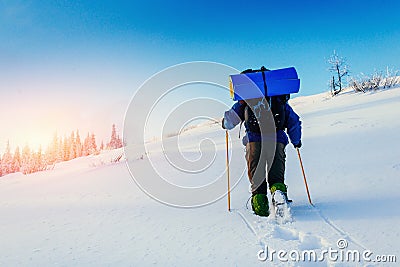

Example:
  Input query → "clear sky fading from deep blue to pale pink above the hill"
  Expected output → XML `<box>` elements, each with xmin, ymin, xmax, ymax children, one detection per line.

<box><xmin>0</xmin><ymin>0</ymin><xmax>400</xmax><ymax>151</ymax></box>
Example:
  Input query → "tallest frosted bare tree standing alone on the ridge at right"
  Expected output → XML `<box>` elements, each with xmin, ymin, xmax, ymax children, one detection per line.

<box><xmin>328</xmin><ymin>50</ymin><xmax>349</xmax><ymax>95</ymax></box>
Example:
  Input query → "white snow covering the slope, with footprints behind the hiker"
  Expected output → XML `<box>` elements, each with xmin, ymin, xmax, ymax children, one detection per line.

<box><xmin>0</xmin><ymin>88</ymin><xmax>400</xmax><ymax>266</ymax></box>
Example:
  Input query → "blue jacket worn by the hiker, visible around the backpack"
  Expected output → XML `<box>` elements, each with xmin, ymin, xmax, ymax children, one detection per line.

<box><xmin>224</xmin><ymin>102</ymin><xmax>301</xmax><ymax>145</ymax></box>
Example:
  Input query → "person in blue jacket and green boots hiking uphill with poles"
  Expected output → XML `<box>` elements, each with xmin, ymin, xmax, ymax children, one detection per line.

<box><xmin>222</xmin><ymin>88</ymin><xmax>302</xmax><ymax>216</ymax></box>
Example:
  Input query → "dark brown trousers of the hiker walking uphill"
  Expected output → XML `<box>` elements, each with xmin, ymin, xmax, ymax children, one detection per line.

<box><xmin>246</xmin><ymin>142</ymin><xmax>286</xmax><ymax>195</ymax></box>
